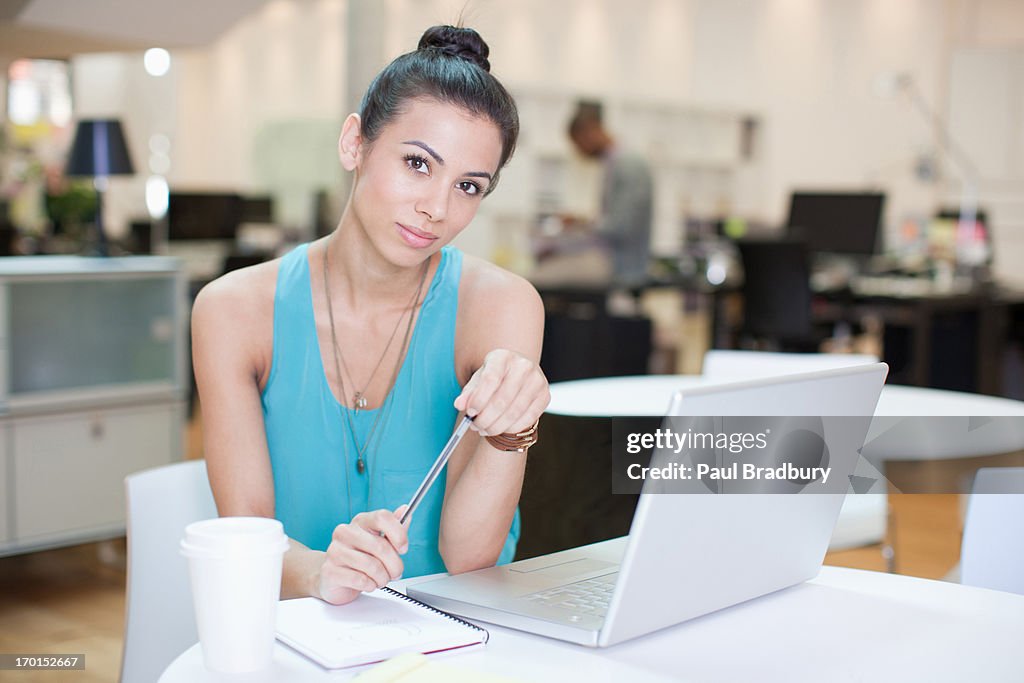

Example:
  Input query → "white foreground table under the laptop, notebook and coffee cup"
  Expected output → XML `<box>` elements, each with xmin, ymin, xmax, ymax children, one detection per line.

<box><xmin>155</xmin><ymin>567</ymin><xmax>1024</xmax><ymax>683</ymax></box>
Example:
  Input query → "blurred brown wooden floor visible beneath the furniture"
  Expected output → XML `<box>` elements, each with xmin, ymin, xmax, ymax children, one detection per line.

<box><xmin>0</xmin><ymin>405</ymin><xmax>962</xmax><ymax>683</ymax></box>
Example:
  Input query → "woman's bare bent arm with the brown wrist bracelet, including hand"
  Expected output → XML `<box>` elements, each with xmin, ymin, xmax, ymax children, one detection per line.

<box><xmin>439</xmin><ymin>257</ymin><xmax>550</xmax><ymax>573</ymax></box>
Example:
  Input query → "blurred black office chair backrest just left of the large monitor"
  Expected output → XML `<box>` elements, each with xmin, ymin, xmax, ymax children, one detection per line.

<box><xmin>736</xmin><ymin>240</ymin><xmax>817</xmax><ymax>351</ymax></box>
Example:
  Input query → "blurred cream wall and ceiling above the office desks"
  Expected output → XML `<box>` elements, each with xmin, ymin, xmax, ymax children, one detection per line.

<box><xmin>0</xmin><ymin>0</ymin><xmax>1024</xmax><ymax>264</ymax></box>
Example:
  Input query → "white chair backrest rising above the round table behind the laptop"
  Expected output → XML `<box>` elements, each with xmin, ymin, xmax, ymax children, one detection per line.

<box><xmin>701</xmin><ymin>349</ymin><xmax>879</xmax><ymax>380</ymax></box>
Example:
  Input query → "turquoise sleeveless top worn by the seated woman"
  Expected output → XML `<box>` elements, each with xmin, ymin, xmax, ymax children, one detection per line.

<box><xmin>262</xmin><ymin>245</ymin><xmax>519</xmax><ymax>578</ymax></box>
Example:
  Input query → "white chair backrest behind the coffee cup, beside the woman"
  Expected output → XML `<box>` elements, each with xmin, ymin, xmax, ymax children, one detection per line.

<box><xmin>121</xmin><ymin>460</ymin><xmax>217</xmax><ymax>683</ymax></box>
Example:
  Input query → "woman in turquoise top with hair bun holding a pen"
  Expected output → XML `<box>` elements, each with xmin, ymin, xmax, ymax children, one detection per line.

<box><xmin>193</xmin><ymin>27</ymin><xmax>549</xmax><ymax>603</ymax></box>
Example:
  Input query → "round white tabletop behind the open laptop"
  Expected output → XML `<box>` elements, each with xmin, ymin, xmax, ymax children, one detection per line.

<box><xmin>547</xmin><ymin>375</ymin><xmax>1024</xmax><ymax>460</ymax></box>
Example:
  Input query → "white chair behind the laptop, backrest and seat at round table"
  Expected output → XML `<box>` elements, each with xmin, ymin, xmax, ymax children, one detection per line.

<box><xmin>703</xmin><ymin>349</ymin><xmax>893</xmax><ymax>557</ymax></box>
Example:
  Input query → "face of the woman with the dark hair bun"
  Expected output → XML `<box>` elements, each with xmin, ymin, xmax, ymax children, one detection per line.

<box><xmin>342</xmin><ymin>99</ymin><xmax>502</xmax><ymax>265</ymax></box>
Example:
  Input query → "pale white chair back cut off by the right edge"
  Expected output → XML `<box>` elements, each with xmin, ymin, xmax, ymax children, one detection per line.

<box><xmin>961</xmin><ymin>467</ymin><xmax>1024</xmax><ymax>594</ymax></box>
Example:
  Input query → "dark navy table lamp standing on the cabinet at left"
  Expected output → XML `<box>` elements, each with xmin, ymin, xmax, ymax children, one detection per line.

<box><xmin>65</xmin><ymin>119</ymin><xmax>135</xmax><ymax>256</ymax></box>
